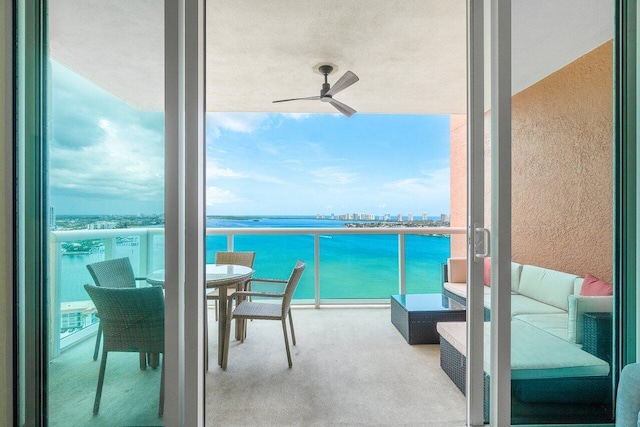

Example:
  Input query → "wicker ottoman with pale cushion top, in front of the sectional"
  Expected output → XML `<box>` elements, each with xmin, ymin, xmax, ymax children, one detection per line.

<box><xmin>437</xmin><ymin>319</ymin><xmax>612</xmax><ymax>424</ymax></box>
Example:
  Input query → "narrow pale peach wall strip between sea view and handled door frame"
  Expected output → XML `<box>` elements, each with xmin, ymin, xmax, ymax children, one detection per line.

<box><xmin>450</xmin><ymin>115</ymin><xmax>467</xmax><ymax>257</ymax></box>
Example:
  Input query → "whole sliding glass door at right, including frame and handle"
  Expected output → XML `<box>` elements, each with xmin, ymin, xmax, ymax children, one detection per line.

<box><xmin>467</xmin><ymin>0</ymin><xmax>617</xmax><ymax>425</ymax></box>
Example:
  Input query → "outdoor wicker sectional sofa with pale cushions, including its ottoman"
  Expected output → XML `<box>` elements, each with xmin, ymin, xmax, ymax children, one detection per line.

<box><xmin>437</xmin><ymin>258</ymin><xmax>613</xmax><ymax>422</ymax></box>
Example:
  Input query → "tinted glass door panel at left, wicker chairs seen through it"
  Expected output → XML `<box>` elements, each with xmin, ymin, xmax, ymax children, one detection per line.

<box><xmin>46</xmin><ymin>1</ymin><xmax>164</xmax><ymax>425</ymax></box>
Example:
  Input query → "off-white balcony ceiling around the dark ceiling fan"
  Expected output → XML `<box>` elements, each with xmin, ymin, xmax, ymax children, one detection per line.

<box><xmin>49</xmin><ymin>0</ymin><xmax>613</xmax><ymax>114</ymax></box>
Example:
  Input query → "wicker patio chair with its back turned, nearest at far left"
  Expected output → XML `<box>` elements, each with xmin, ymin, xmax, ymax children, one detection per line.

<box><xmin>84</xmin><ymin>285</ymin><xmax>164</xmax><ymax>416</ymax></box>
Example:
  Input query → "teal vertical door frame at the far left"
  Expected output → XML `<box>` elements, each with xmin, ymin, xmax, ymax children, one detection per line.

<box><xmin>13</xmin><ymin>0</ymin><xmax>48</xmax><ymax>425</ymax></box>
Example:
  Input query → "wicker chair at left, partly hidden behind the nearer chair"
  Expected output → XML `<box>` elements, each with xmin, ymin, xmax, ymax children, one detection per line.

<box><xmin>87</xmin><ymin>258</ymin><xmax>146</xmax><ymax>369</ymax></box>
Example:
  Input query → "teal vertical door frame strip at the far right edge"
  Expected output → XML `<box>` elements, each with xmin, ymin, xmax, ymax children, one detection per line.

<box><xmin>614</xmin><ymin>0</ymin><xmax>640</xmax><ymax>372</ymax></box>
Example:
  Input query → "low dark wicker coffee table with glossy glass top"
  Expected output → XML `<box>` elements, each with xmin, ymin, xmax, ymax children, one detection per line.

<box><xmin>391</xmin><ymin>294</ymin><xmax>467</xmax><ymax>345</ymax></box>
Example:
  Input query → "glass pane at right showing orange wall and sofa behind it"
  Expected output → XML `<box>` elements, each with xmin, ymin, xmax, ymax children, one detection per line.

<box><xmin>511</xmin><ymin>0</ymin><xmax>614</xmax><ymax>424</ymax></box>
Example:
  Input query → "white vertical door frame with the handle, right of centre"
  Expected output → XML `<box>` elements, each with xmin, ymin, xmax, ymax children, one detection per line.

<box><xmin>466</xmin><ymin>0</ymin><xmax>511</xmax><ymax>426</ymax></box>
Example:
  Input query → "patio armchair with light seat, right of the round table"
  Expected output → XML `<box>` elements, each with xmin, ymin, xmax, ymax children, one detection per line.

<box><xmin>222</xmin><ymin>261</ymin><xmax>306</xmax><ymax>369</ymax></box>
